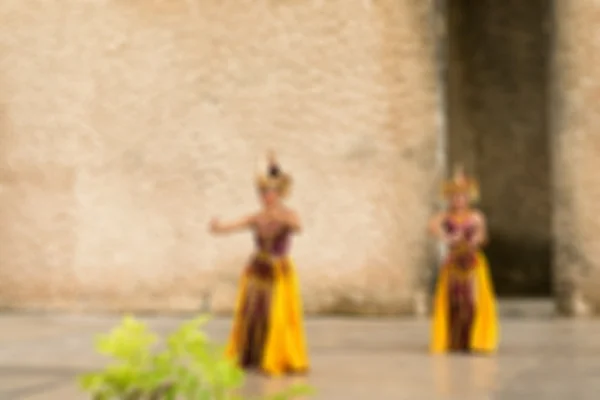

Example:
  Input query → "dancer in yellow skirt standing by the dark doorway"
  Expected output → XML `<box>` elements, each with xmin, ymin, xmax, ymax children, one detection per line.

<box><xmin>430</xmin><ymin>169</ymin><xmax>499</xmax><ymax>353</ymax></box>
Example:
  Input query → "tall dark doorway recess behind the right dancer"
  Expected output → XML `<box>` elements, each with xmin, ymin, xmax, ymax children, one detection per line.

<box><xmin>445</xmin><ymin>0</ymin><xmax>552</xmax><ymax>297</ymax></box>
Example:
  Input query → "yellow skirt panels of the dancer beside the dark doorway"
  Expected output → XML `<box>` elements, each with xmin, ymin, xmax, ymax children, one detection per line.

<box><xmin>430</xmin><ymin>252</ymin><xmax>499</xmax><ymax>353</ymax></box>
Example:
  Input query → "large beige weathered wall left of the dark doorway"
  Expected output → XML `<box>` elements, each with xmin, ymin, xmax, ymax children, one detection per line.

<box><xmin>0</xmin><ymin>0</ymin><xmax>440</xmax><ymax>313</ymax></box>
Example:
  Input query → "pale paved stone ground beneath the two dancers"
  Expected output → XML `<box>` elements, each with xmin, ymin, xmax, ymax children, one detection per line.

<box><xmin>0</xmin><ymin>307</ymin><xmax>600</xmax><ymax>400</ymax></box>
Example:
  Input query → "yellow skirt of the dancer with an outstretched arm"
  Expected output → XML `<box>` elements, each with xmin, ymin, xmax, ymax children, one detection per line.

<box><xmin>226</xmin><ymin>258</ymin><xmax>309</xmax><ymax>376</ymax></box>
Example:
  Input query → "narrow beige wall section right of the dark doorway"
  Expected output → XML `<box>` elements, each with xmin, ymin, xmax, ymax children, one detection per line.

<box><xmin>552</xmin><ymin>0</ymin><xmax>600</xmax><ymax>314</ymax></box>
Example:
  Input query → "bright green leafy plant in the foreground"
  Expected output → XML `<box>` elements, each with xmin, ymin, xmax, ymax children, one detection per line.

<box><xmin>80</xmin><ymin>316</ymin><xmax>310</xmax><ymax>400</ymax></box>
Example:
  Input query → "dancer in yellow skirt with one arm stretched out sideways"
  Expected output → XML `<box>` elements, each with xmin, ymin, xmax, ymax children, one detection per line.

<box><xmin>211</xmin><ymin>154</ymin><xmax>308</xmax><ymax>375</ymax></box>
